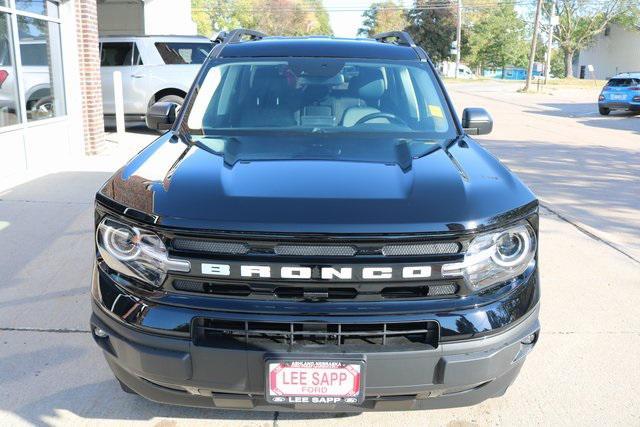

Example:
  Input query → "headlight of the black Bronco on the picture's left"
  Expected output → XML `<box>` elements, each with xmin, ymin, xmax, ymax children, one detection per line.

<box><xmin>96</xmin><ymin>217</ymin><xmax>191</xmax><ymax>287</ymax></box>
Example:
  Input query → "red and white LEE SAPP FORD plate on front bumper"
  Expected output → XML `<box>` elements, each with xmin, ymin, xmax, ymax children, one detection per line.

<box><xmin>267</xmin><ymin>360</ymin><xmax>364</xmax><ymax>404</ymax></box>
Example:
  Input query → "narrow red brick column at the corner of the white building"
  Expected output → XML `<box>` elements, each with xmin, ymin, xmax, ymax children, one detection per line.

<box><xmin>75</xmin><ymin>0</ymin><xmax>105</xmax><ymax>154</ymax></box>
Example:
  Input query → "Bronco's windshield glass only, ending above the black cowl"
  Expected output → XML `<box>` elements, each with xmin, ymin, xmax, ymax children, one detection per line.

<box><xmin>186</xmin><ymin>58</ymin><xmax>455</xmax><ymax>138</ymax></box>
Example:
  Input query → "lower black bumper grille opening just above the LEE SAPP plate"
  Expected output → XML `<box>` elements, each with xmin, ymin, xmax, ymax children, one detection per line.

<box><xmin>193</xmin><ymin>318</ymin><xmax>439</xmax><ymax>351</ymax></box>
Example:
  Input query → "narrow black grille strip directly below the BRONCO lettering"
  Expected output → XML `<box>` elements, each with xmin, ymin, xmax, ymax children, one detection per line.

<box><xmin>173</xmin><ymin>279</ymin><xmax>459</xmax><ymax>301</ymax></box>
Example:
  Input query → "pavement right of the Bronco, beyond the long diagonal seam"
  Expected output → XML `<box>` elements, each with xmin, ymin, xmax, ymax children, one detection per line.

<box><xmin>449</xmin><ymin>82</ymin><xmax>640</xmax><ymax>260</ymax></box>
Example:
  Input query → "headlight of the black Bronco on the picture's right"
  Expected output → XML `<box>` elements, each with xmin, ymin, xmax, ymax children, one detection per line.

<box><xmin>442</xmin><ymin>223</ymin><xmax>536</xmax><ymax>291</ymax></box>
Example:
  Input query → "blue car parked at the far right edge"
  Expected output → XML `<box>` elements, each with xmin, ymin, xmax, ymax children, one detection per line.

<box><xmin>598</xmin><ymin>72</ymin><xmax>640</xmax><ymax>116</ymax></box>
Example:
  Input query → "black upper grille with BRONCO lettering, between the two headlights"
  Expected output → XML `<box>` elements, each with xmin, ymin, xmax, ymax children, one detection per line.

<box><xmin>166</xmin><ymin>234</ymin><xmax>467</xmax><ymax>301</ymax></box>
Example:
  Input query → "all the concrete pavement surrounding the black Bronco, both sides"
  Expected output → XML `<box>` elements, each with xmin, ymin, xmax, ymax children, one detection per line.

<box><xmin>0</xmin><ymin>82</ymin><xmax>640</xmax><ymax>427</ymax></box>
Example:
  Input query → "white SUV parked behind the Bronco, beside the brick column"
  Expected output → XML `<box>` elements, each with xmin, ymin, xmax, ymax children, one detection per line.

<box><xmin>100</xmin><ymin>36</ymin><xmax>213</xmax><ymax>123</ymax></box>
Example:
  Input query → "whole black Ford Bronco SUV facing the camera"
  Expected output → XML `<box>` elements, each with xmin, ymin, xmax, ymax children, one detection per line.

<box><xmin>91</xmin><ymin>30</ymin><xmax>540</xmax><ymax>412</ymax></box>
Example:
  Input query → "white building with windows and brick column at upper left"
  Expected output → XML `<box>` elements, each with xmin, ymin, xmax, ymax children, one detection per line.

<box><xmin>0</xmin><ymin>0</ymin><xmax>195</xmax><ymax>182</ymax></box>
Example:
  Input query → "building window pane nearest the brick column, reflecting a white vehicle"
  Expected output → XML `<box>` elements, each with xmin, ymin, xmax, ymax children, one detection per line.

<box><xmin>18</xmin><ymin>16</ymin><xmax>65</xmax><ymax>121</ymax></box>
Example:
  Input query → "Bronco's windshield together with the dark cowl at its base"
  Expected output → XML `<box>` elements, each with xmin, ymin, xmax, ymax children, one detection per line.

<box><xmin>182</xmin><ymin>58</ymin><xmax>457</xmax><ymax>169</ymax></box>
